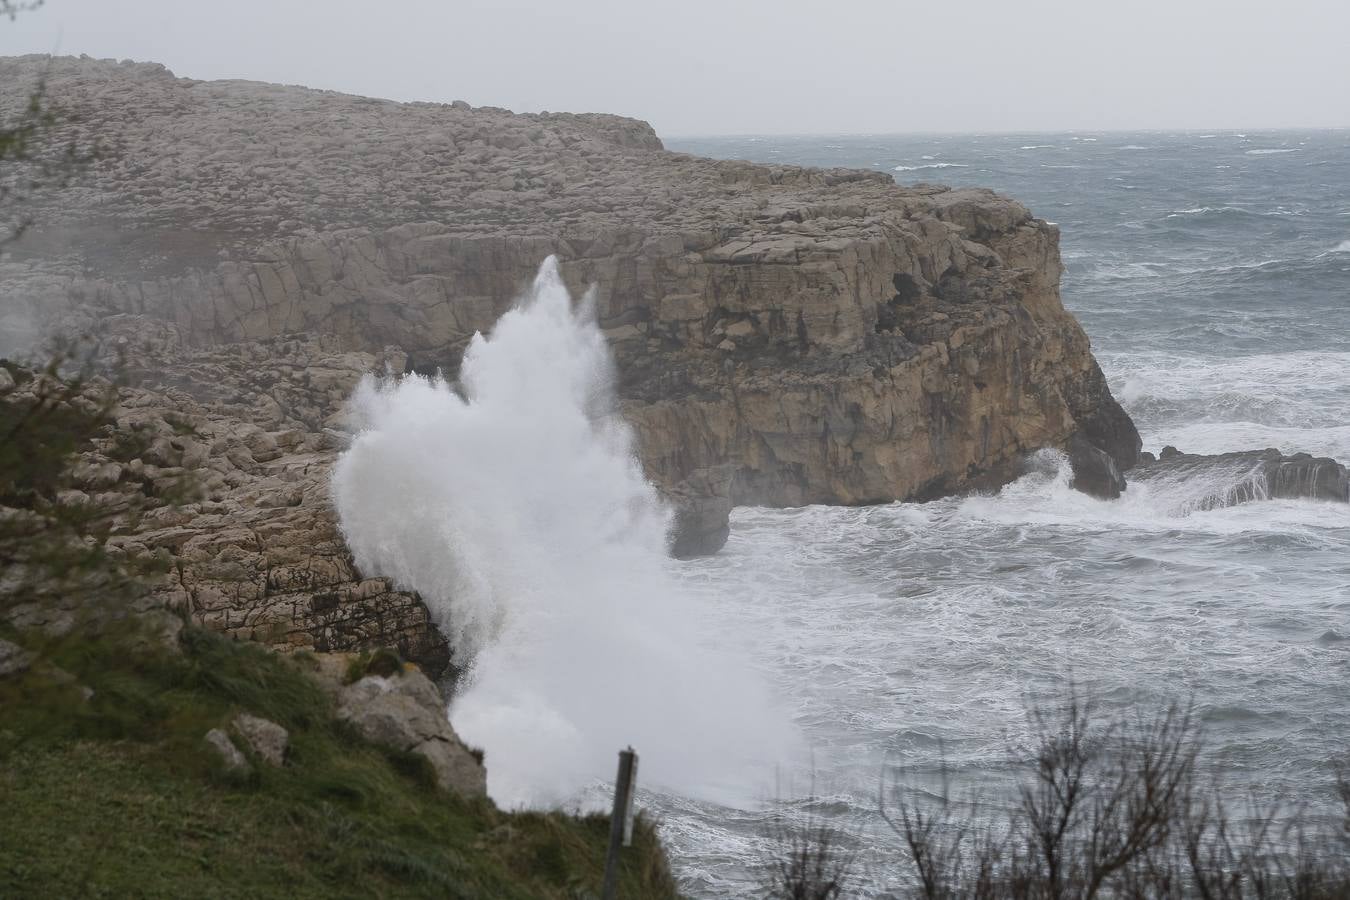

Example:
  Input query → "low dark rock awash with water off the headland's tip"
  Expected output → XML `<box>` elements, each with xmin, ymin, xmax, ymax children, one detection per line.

<box><xmin>1131</xmin><ymin>447</ymin><xmax>1350</xmax><ymax>510</ymax></box>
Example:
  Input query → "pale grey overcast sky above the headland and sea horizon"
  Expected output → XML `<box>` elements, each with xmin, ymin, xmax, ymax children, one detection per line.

<box><xmin>0</xmin><ymin>0</ymin><xmax>1350</xmax><ymax>136</ymax></box>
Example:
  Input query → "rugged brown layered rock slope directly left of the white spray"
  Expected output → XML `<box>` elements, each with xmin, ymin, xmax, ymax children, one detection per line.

<box><xmin>0</xmin><ymin>316</ymin><xmax>450</xmax><ymax>675</ymax></box>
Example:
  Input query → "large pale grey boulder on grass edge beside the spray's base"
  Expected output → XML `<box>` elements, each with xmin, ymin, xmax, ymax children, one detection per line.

<box><xmin>338</xmin><ymin>668</ymin><xmax>487</xmax><ymax>797</ymax></box>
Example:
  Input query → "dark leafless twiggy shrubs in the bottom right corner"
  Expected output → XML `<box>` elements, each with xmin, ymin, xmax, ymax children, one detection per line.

<box><xmin>882</xmin><ymin>695</ymin><xmax>1350</xmax><ymax>900</ymax></box>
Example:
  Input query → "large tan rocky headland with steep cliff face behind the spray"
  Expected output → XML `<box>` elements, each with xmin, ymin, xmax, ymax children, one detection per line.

<box><xmin>0</xmin><ymin>52</ymin><xmax>1139</xmax><ymax>666</ymax></box>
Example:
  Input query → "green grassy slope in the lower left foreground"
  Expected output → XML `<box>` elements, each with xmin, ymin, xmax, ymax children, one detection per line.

<box><xmin>0</xmin><ymin>631</ymin><xmax>678</xmax><ymax>900</ymax></box>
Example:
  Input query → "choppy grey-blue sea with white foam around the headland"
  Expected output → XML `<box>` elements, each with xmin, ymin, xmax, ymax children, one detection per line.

<box><xmin>656</xmin><ymin>131</ymin><xmax>1350</xmax><ymax>897</ymax></box>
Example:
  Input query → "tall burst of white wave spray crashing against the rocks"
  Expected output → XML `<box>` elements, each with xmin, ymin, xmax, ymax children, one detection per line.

<box><xmin>333</xmin><ymin>258</ymin><xmax>795</xmax><ymax>807</ymax></box>
